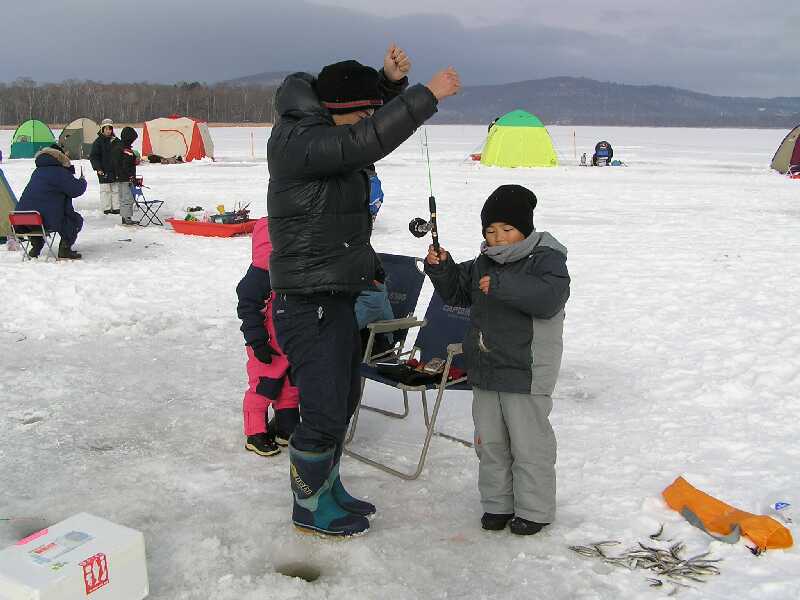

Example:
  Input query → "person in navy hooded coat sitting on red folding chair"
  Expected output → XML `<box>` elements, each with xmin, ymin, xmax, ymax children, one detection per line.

<box><xmin>17</xmin><ymin>144</ymin><xmax>86</xmax><ymax>260</ymax></box>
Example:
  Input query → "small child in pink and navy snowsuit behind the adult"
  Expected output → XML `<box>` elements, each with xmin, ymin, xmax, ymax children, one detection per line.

<box><xmin>236</xmin><ymin>217</ymin><xmax>300</xmax><ymax>456</ymax></box>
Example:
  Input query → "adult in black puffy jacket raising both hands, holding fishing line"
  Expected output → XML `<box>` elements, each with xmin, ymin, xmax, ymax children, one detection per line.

<box><xmin>267</xmin><ymin>45</ymin><xmax>460</xmax><ymax>536</ymax></box>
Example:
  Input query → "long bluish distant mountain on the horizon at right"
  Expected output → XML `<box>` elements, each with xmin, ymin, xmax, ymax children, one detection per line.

<box><xmin>435</xmin><ymin>77</ymin><xmax>800</xmax><ymax>127</ymax></box>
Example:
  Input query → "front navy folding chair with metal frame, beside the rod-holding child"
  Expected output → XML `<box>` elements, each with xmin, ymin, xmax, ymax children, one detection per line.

<box><xmin>345</xmin><ymin>292</ymin><xmax>472</xmax><ymax>480</ymax></box>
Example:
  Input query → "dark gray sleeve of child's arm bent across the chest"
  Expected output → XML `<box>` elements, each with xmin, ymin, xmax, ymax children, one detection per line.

<box><xmin>489</xmin><ymin>251</ymin><xmax>570</xmax><ymax>319</ymax></box>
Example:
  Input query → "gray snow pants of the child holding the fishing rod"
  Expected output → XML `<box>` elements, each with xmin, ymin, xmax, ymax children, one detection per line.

<box><xmin>472</xmin><ymin>388</ymin><xmax>556</xmax><ymax>523</ymax></box>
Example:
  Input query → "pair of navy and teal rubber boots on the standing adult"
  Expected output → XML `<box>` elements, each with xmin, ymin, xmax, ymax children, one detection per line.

<box><xmin>289</xmin><ymin>443</ymin><xmax>369</xmax><ymax>536</ymax></box>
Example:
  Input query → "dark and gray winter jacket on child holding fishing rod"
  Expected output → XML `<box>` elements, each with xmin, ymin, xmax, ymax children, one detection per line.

<box><xmin>425</xmin><ymin>232</ymin><xmax>570</xmax><ymax>394</ymax></box>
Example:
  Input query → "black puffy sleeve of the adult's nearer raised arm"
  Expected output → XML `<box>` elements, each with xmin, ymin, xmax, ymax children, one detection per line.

<box><xmin>283</xmin><ymin>84</ymin><xmax>437</xmax><ymax>179</ymax></box>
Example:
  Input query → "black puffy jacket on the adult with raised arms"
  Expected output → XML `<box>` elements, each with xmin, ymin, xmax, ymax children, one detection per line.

<box><xmin>267</xmin><ymin>72</ymin><xmax>437</xmax><ymax>294</ymax></box>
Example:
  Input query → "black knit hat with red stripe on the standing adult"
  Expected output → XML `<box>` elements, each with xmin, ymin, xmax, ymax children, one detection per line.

<box><xmin>317</xmin><ymin>60</ymin><xmax>383</xmax><ymax>115</ymax></box>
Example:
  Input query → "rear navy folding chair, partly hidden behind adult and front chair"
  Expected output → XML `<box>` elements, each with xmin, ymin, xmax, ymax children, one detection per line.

<box><xmin>361</xmin><ymin>254</ymin><xmax>425</xmax><ymax>419</ymax></box>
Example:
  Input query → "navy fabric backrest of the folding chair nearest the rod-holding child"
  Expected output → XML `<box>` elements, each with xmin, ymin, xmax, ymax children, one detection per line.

<box><xmin>415</xmin><ymin>291</ymin><xmax>469</xmax><ymax>369</ymax></box>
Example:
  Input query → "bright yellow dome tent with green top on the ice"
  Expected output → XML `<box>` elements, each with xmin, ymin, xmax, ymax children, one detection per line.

<box><xmin>481</xmin><ymin>110</ymin><xmax>558</xmax><ymax>167</ymax></box>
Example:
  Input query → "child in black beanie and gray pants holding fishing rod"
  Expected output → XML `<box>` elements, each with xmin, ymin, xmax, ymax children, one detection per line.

<box><xmin>425</xmin><ymin>185</ymin><xmax>570</xmax><ymax>535</ymax></box>
